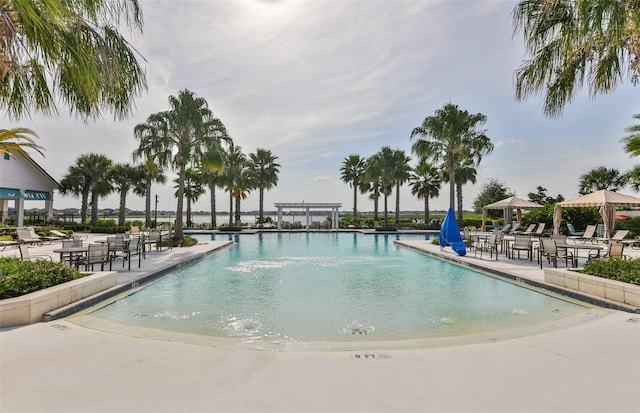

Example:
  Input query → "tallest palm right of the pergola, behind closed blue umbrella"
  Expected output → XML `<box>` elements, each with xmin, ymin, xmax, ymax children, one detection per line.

<box><xmin>411</xmin><ymin>103</ymin><xmax>493</xmax><ymax>217</ymax></box>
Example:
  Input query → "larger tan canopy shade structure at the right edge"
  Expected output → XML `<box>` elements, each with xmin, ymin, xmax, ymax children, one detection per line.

<box><xmin>553</xmin><ymin>189</ymin><xmax>640</xmax><ymax>238</ymax></box>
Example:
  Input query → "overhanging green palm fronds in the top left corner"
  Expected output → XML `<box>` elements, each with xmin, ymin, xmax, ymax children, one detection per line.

<box><xmin>0</xmin><ymin>0</ymin><xmax>146</xmax><ymax>119</ymax></box>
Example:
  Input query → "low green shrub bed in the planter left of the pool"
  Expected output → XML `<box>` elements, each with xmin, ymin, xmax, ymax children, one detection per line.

<box><xmin>0</xmin><ymin>257</ymin><xmax>86</xmax><ymax>299</ymax></box>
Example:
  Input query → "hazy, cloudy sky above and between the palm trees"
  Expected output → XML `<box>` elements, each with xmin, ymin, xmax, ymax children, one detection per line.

<box><xmin>0</xmin><ymin>0</ymin><xmax>640</xmax><ymax>212</ymax></box>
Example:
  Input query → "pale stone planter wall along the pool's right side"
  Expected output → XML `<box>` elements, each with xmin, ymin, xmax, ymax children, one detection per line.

<box><xmin>544</xmin><ymin>268</ymin><xmax>640</xmax><ymax>308</ymax></box>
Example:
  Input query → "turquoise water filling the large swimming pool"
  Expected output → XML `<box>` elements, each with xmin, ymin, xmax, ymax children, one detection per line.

<box><xmin>91</xmin><ymin>233</ymin><xmax>586</xmax><ymax>342</ymax></box>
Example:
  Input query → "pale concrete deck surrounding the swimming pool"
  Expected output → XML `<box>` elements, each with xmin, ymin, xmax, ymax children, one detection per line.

<box><xmin>0</xmin><ymin>232</ymin><xmax>640</xmax><ymax>412</ymax></box>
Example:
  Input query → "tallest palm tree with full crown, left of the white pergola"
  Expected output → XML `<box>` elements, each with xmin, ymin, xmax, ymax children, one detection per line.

<box><xmin>134</xmin><ymin>90</ymin><xmax>229</xmax><ymax>239</ymax></box>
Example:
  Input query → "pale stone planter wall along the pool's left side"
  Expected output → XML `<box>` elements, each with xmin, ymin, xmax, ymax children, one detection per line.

<box><xmin>0</xmin><ymin>271</ymin><xmax>118</xmax><ymax>327</ymax></box>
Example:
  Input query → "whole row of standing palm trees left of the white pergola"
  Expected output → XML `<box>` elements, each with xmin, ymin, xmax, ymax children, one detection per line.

<box><xmin>60</xmin><ymin>90</ymin><xmax>280</xmax><ymax>238</ymax></box>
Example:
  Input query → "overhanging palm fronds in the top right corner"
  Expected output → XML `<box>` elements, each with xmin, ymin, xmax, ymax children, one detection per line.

<box><xmin>513</xmin><ymin>0</ymin><xmax>640</xmax><ymax>117</ymax></box>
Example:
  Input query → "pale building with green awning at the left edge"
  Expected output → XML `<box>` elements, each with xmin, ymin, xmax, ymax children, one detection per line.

<box><xmin>0</xmin><ymin>152</ymin><xmax>60</xmax><ymax>227</ymax></box>
